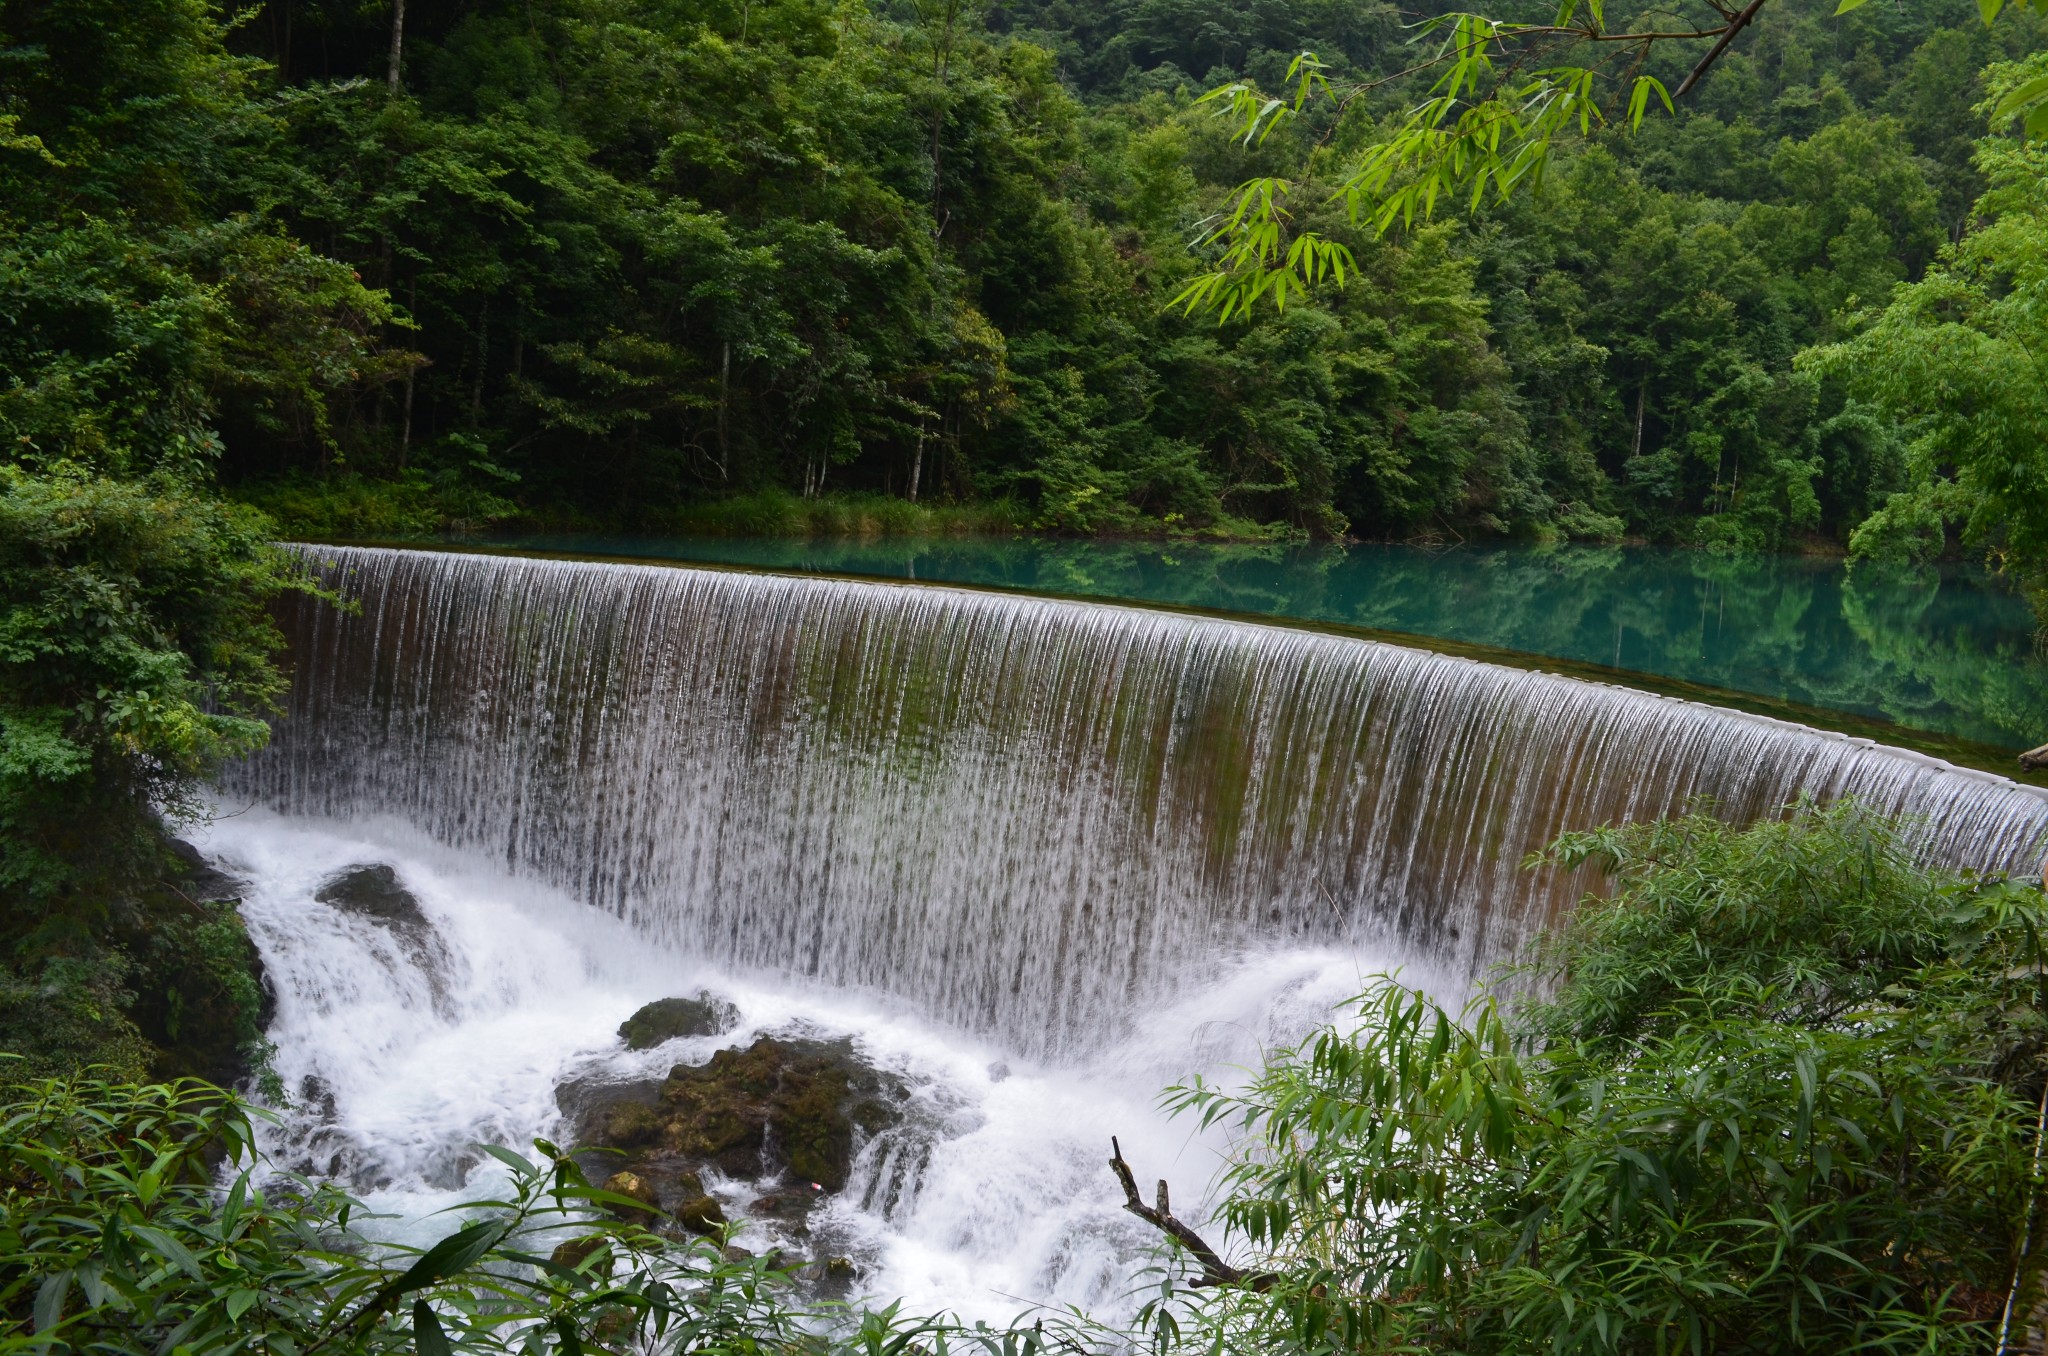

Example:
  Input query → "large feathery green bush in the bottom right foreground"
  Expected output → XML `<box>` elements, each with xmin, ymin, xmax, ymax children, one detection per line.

<box><xmin>1153</xmin><ymin>803</ymin><xmax>2048</xmax><ymax>1352</ymax></box>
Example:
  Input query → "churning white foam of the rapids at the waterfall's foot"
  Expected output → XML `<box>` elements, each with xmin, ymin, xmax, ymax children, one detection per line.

<box><xmin>203</xmin><ymin>811</ymin><xmax>1374</xmax><ymax>1321</ymax></box>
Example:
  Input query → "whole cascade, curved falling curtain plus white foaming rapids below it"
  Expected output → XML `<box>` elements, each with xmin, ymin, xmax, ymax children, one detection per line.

<box><xmin>211</xmin><ymin>547</ymin><xmax>2048</xmax><ymax>1313</ymax></box>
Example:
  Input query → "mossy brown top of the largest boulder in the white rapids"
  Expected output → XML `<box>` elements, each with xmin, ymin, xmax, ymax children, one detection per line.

<box><xmin>659</xmin><ymin>1036</ymin><xmax>907</xmax><ymax>1190</ymax></box>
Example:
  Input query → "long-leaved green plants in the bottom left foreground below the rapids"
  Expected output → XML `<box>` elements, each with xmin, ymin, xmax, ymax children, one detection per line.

<box><xmin>0</xmin><ymin>1077</ymin><xmax>1047</xmax><ymax>1356</ymax></box>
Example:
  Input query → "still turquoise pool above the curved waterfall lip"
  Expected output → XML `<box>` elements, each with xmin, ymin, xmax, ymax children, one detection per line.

<box><xmin>464</xmin><ymin>537</ymin><xmax>2048</xmax><ymax>750</ymax></box>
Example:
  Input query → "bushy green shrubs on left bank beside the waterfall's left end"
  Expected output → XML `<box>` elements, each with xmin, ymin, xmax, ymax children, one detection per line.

<box><xmin>0</xmin><ymin>473</ymin><xmax>299</xmax><ymax>1077</ymax></box>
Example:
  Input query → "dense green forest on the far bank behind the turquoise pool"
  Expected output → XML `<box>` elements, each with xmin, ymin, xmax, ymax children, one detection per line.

<box><xmin>0</xmin><ymin>0</ymin><xmax>2048</xmax><ymax>594</ymax></box>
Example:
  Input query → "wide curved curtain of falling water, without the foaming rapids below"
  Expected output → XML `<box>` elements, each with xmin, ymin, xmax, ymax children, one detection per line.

<box><xmin>227</xmin><ymin>547</ymin><xmax>2048</xmax><ymax>1057</ymax></box>
